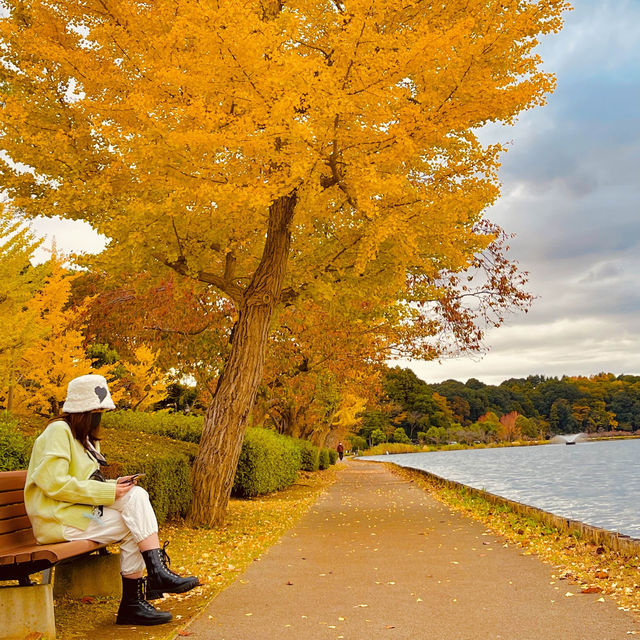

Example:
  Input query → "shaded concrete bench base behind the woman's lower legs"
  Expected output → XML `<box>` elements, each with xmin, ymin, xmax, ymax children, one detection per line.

<box><xmin>53</xmin><ymin>553</ymin><xmax>122</xmax><ymax>598</ymax></box>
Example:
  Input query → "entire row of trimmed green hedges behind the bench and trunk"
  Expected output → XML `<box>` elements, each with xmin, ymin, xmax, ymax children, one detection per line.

<box><xmin>0</xmin><ymin>411</ymin><xmax>338</xmax><ymax>523</ymax></box>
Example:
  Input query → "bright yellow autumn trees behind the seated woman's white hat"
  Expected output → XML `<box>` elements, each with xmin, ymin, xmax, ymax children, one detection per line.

<box><xmin>0</xmin><ymin>222</ymin><xmax>167</xmax><ymax>416</ymax></box>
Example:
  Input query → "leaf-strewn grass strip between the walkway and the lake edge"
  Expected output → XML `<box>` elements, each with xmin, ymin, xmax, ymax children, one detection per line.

<box><xmin>386</xmin><ymin>464</ymin><xmax>640</xmax><ymax>614</ymax></box>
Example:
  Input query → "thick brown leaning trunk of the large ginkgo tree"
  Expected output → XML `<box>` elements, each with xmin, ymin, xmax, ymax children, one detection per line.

<box><xmin>188</xmin><ymin>191</ymin><xmax>296</xmax><ymax>526</ymax></box>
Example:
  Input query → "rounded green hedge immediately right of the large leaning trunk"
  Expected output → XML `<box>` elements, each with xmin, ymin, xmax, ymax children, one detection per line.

<box><xmin>233</xmin><ymin>428</ymin><xmax>301</xmax><ymax>498</ymax></box>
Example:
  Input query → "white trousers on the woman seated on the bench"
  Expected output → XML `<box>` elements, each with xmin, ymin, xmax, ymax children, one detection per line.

<box><xmin>63</xmin><ymin>486</ymin><xmax>158</xmax><ymax>576</ymax></box>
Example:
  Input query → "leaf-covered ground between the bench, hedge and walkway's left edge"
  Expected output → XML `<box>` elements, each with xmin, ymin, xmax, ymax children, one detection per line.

<box><xmin>56</xmin><ymin>467</ymin><xmax>337</xmax><ymax>640</ymax></box>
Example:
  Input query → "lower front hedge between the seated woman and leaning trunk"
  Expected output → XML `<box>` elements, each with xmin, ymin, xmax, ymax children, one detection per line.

<box><xmin>100</xmin><ymin>427</ymin><xmax>198</xmax><ymax>523</ymax></box>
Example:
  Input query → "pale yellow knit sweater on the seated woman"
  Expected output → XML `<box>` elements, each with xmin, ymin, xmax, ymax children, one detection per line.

<box><xmin>24</xmin><ymin>420</ymin><xmax>116</xmax><ymax>544</ymax></box>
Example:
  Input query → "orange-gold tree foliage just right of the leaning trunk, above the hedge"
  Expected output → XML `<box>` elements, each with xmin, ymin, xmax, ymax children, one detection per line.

<box><xmin>254</xmin><ymin>299</ymin><xmax>389</xmax><ymax>445</ymax></box>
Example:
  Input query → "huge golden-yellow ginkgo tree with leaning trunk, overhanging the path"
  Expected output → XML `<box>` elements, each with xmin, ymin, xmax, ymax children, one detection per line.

<box><xmin>0</xmin><ymin>0</ymin><xmax>568</xmax><ymax>524</ymax></box>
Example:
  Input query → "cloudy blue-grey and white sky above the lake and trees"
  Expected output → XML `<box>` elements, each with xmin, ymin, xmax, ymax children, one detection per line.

<box><xmin>30</xmin><ymin>0</ymin><xmax>640</xmax><ymax>383</ymax></box>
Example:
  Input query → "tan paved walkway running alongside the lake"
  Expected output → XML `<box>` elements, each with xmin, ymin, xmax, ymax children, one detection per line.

<box><xmin>188</xmin><ymin>461</ymin><xmax>640</xmax><ymax>640</ymax></box>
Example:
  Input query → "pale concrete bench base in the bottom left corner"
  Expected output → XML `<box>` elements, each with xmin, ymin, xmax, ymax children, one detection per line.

<box><xmin>0</xmin><ymin>584</ymin><xmax>56</xmax><ymax>640</ymax></box>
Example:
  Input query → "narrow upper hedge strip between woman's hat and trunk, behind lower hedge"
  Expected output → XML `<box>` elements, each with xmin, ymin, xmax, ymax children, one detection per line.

<box><xmin>102</xmin><ymin>411</ymin><xmax>204</xmax><ymax>444</ymax></box>
